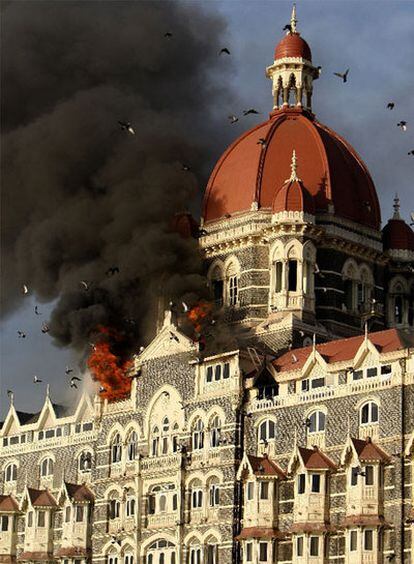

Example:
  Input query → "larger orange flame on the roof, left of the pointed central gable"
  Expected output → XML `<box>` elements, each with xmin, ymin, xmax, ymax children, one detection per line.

<box><xmin>87</xmin><ymin>327</ymin><xmax>132</xmax><ymax>401</ymax></box>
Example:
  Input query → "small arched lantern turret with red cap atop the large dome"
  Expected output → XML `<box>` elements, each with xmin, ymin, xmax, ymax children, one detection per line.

<box><xmin>266</xmin><ymin>4</ymin><xmax>320</xmax><ymax>110</ymax></box>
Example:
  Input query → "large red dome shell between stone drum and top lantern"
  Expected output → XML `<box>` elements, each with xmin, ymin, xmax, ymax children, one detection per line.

<box><xmin>203</xmin><ymin>108</ymin><xmax>381</xmax><ymax>229</ymax></box>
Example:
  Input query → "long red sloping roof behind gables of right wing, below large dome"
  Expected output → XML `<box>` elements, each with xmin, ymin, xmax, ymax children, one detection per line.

<box><xmin>272</xmin><ymin>329</ymin><xmax>414</xmax><ymax>372</ymax></box>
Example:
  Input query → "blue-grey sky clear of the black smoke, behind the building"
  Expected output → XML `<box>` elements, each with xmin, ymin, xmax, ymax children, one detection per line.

<box><xmin>0</xmin><ymin>0</ymin><xmax>414</xmax><ymax>417</ymax></box>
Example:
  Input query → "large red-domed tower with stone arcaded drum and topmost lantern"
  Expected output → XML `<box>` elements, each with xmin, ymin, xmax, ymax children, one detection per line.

<box><xmin>200</xmin><ymin>5</ymin><xmax>386</xmax><ymax>347</ymax></box>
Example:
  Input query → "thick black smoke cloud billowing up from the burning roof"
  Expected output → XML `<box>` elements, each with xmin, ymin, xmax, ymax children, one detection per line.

<box><xmin>1</xmin><ymin>0</ymin><xmax>233</xmax><ymax>366</ymax></box>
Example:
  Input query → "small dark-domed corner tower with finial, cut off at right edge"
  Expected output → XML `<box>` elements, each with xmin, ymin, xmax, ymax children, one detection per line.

<box><xmin>382</xmin><ymin>194</ymin><xmax>414</xmax><ymax>329</ymax></box>
